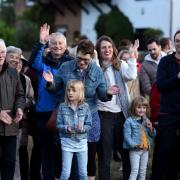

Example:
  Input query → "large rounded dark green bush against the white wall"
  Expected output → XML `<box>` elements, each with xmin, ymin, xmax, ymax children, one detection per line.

<box><xmin>95</xmin><ymin>6</ymin><xmax>134</xmax><ymax>45</ymax></box>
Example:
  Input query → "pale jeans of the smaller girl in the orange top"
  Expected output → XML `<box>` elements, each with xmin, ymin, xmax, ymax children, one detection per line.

<box><xmin>129</xmin><ymin>150</ymin><xmax>148</xmax><ymax>180</ymax></box>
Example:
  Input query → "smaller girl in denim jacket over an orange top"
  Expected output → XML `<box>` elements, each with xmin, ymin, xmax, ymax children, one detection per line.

<box><xmin>123</xmin><ymin>96</ymin><xmax>156</xmax><ymax>180</ymax></box>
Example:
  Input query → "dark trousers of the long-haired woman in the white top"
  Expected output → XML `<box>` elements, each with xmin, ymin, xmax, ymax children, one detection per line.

<box><xmin>98</xmin><ymin>111</ymin><xmax>130</xmax><ymax>180</ymax></box>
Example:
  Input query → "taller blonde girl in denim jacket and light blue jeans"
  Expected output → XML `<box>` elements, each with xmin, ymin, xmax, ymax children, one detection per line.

<box><xmin>56</xmin><ymin>80</ymin><xmax>92</xmax><ymax>180</ymax></box>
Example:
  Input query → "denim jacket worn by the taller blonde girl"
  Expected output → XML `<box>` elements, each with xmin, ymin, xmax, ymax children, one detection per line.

<box><xmin>56</xmin><ymin>103</ymin><xmax>92</xmax><ymax>141</ymax></box>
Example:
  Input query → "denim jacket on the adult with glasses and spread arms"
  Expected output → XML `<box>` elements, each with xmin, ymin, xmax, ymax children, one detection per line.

<box><xmin>47</xmin><ymin>61</ymin><xmax>112</xmax><ymax>113</ymax></box>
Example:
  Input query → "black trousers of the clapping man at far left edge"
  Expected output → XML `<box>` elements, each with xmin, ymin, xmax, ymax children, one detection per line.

<box><xmin>0</xmin><ymin>136</ymin><xmax>17</xmax><ymax>180</ymax></box>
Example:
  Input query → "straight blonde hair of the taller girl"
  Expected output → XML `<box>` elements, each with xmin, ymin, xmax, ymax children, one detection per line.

<box><xmin>65</xmin><ymin>80</ymin><xmax>85</xmax><ymax>104</ymax></box>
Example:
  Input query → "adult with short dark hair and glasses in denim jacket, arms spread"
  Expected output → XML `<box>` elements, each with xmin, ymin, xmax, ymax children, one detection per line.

<box><xmin>44</xmin><ymin>40</ymin><xmax>119</xmax><ymax>179</ymax></box>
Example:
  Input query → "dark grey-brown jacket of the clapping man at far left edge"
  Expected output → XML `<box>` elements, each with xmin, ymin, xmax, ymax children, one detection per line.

<box><xmin>0</xmin><ymin>64</ymin><xmax>25</xmax><ymax>136</ymax></box>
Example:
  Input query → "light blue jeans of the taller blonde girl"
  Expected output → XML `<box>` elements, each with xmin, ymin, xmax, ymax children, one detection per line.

<box><xmin>60</xmin><ymin>151</ymin><xmax>88</xmax><ymax>180</ymax></box>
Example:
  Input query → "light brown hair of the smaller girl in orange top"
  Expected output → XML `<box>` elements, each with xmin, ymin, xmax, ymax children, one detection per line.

<box><xmin>130</xmin><ymin>96</ymin><xmax>150</xmax><ymax>117</ymax></box>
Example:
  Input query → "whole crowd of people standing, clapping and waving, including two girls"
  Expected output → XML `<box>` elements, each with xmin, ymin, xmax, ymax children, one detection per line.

<box><xmin>0</xmin><ymin>24</ymin><xmax>180</xmax><ymax>180</ymax></box>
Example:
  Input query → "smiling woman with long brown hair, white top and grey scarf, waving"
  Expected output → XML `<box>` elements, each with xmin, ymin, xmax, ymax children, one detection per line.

<box><xmin>96</xmin><ymin>35</ymin><xmax>137</xmax><ymax>180</ymax></box>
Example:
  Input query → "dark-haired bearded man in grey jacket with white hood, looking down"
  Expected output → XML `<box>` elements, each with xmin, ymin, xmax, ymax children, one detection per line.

<box><xmin>139</xmin><ymin>39</ymin><xmax>166</xmax><ymax>96</ymax></box>
